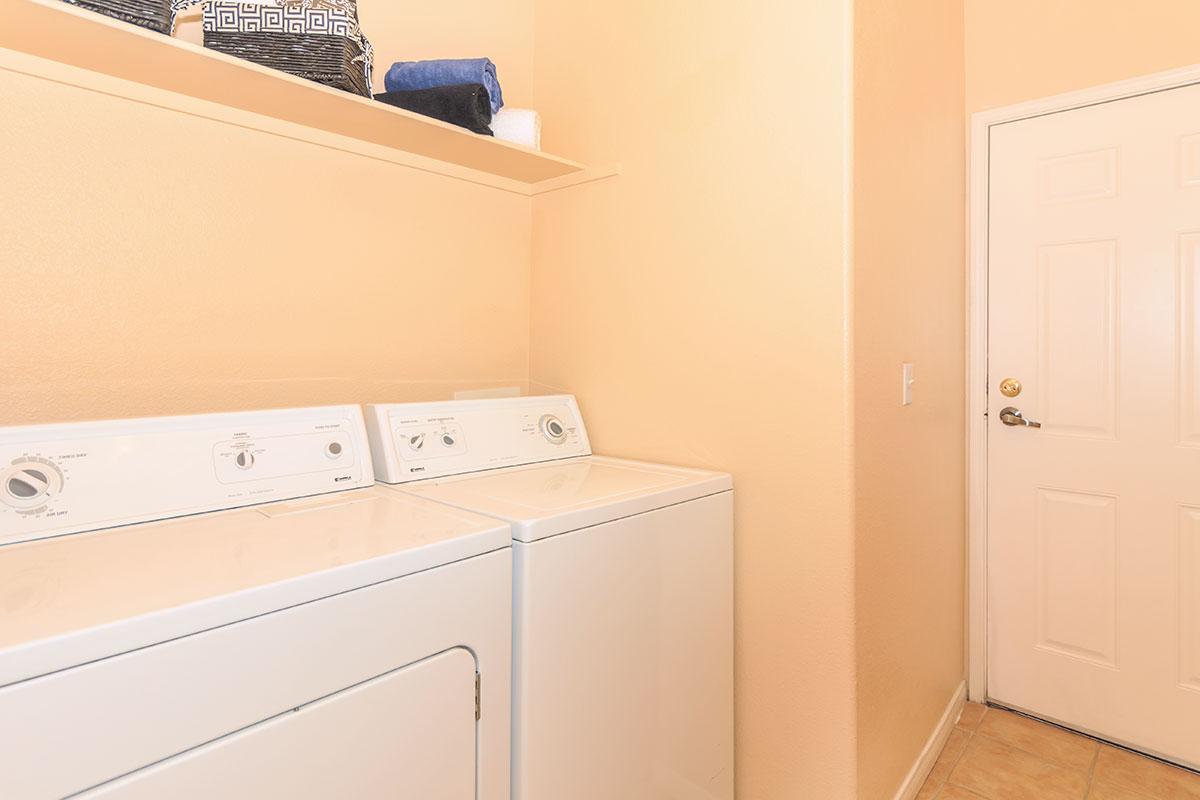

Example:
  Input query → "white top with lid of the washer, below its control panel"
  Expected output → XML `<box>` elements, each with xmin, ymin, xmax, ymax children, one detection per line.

<box><xmin>397</xmin><ymin>456</ymin><xmax>733</xmax><ymax>542</ymax></box>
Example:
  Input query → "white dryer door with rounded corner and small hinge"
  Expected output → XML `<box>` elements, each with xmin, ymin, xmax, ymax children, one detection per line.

<box><xmin>79</xmin><ymin>648</ymin><xmax>475</xmax><ymax>800</ymax></box>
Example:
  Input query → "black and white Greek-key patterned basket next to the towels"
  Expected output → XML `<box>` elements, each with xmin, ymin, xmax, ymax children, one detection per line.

<box><xmin>187</xmin><ymin>0</ymin><xmax>372</xmax><ymax>97</ymax></box>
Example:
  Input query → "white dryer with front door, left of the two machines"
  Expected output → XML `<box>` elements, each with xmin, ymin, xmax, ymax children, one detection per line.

<box><xmin>0</xmin><ymin>407</ymin><xmax>511</xmax><ymax>800</ymax></box>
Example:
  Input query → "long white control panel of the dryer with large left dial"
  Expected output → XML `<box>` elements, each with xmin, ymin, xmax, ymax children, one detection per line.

<box><xmin>0</xmin><ymin>405</ymin><xmax>374</xmax><ymax>546</ymax></box>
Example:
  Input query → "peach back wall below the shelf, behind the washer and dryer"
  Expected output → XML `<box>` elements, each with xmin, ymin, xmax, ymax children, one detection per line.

<box><xmin>0</xmin><ymin>0</ymin><xmax>532</xmax><ymax>425</ymax></box>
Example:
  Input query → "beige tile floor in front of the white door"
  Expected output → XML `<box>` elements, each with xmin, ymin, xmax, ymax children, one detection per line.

<box><xmin>917</xmin><ymin>703</ymin><xmax>1200</xmax><ymax>800</ymax></box>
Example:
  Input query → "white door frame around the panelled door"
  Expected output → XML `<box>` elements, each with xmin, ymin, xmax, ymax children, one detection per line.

<box><xmin>966</xmin><ymin>65</ymin><xmax>1200</xmax><ymax>703</ymax></box>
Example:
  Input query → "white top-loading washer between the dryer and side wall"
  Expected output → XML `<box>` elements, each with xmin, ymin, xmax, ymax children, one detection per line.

<box><xmin>367</xmin><ymin>396</ymin><xmax>733</xmax><ymax>800</ymax></box>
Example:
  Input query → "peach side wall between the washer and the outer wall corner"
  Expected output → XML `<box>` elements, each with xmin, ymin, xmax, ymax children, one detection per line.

<box><xmin>530</xmin><ymin>0</ymin><xmax>854</xmax><ymax>800</ymax></box>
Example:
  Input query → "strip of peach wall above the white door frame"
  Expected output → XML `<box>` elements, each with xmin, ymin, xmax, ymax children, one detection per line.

<box><xmin>965</xmin><ymin>0</ymin><xmax>1200</xmax><ymax>112</ymax></box>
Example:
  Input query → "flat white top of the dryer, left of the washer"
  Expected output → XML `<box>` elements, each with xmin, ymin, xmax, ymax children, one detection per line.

<box><xmin>0</xmin><ymin>487</ymin><xmax>510</xmax><ymax>686</ymax></box>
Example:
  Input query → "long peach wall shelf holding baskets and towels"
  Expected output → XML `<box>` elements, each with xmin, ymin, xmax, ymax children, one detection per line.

<box><xmin>0</xmin><ymin>0</ymin><xmax>595</xmax><ymax>193</ymax></box>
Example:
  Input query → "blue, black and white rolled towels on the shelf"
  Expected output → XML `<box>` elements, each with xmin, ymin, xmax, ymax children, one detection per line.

<box><xmin>376</xmin><ymin>59</ymin><xmax>541</xmax><ymax>149</ymax></box>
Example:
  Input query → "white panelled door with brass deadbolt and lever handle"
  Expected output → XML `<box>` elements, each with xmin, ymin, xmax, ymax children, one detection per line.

<box><xmin>988</xmin><ymin>81</ymin><xmax>1200</xmax><ymax>765</ymax></box>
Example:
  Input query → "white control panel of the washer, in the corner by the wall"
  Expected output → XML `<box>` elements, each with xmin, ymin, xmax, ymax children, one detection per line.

<box><xmin>367</xmin><ymin>395</ymin><xmax>592</xmax><ymax>483</ymax></box>
